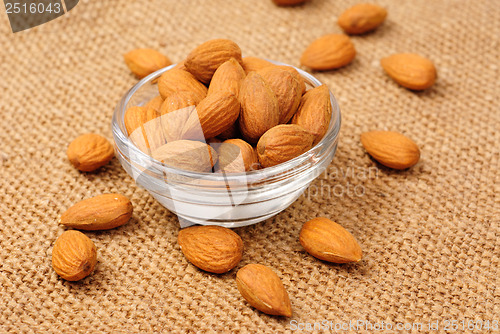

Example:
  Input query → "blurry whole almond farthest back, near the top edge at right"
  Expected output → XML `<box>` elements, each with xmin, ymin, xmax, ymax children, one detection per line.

<box><xmin>338</xmin><ymin>3</ymin><xmax>387</xmax><ymax>35</ymax></box>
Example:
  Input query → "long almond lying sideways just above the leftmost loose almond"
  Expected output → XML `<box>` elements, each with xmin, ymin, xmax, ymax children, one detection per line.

<box><xmin>59</xmin><ymin>194</ymin><xmax>133</xmax><ymax>231</ymax></box>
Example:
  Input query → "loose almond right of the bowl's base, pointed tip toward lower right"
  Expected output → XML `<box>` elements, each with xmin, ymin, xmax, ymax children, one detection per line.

<box><xmin>299</xmin><ymin>217</ymin><xmax>363</xmax><ymax>263</ymax></box>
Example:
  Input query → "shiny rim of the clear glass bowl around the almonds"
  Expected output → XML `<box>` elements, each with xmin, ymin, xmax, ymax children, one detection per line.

<box><xmin>111</xmin><ymin>58</ymin><xmax>342</xmax><ymax>183</ymax></box>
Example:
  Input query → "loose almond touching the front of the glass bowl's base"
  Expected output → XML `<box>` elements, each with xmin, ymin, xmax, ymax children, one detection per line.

<box><xmin>177</xmin><ymin>226</ymin><xmax>243</xmax><ymax>274</ymax></box>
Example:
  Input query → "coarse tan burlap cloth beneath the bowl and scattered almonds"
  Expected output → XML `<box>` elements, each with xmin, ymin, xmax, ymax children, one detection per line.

<box><xmin>0</xmin><ymin>0</ymin><xmax>500</xmax><ymax>333</ymax></box>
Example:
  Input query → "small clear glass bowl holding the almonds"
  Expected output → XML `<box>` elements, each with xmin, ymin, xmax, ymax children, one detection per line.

<box><xmin>112</xmin><ymin>61</ymin><xmax>340</xmax><ymax>228</ymax></box>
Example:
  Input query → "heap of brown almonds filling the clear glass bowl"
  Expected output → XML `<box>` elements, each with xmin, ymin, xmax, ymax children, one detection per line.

<box><xmin>125</xmin><ymin>39</ymin><xmax>332</xmax><ymax>172</ymax></box>
